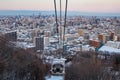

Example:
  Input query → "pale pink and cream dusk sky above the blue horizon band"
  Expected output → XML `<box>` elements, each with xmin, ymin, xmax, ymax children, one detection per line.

<box><xmin>0</xmin><ymin>0</ymin><xmax>120</xmax><ymax>13</ymax></box>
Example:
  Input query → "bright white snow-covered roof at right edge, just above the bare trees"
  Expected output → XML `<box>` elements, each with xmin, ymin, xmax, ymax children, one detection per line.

<box><xmin>99</xmin><ymin>46</ymin><xmax>120</xmax><ymax>54</ymax></box>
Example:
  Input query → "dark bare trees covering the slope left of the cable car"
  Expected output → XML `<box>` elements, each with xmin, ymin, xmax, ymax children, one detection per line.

<box><xmin>0</xmin><ymin>37</ymin><xmax>49</xmax><ymax>80</ymax></box>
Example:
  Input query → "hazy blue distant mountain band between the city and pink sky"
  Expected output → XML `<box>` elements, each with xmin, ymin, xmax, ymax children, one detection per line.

<box><xmin>0</xmin><ymin>10</ymin><xmax>120</xmax><ymax>17</ymax></box>
